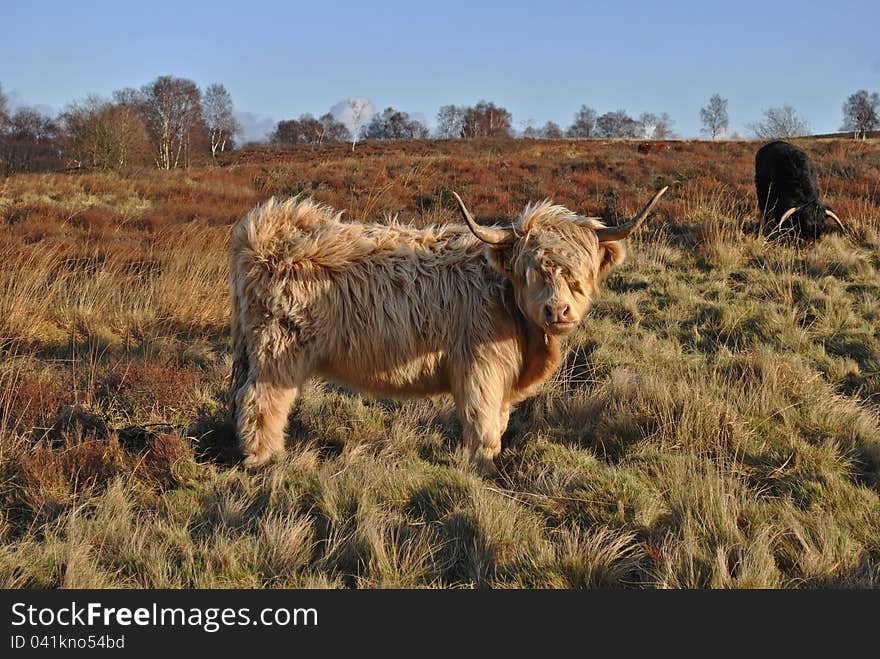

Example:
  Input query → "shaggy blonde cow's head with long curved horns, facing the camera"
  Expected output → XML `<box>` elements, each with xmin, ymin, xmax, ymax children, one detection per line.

<box><xmin>453</xmin><ymin>187</ymin><xmax>668</xmax><ymax>335</ymax></box>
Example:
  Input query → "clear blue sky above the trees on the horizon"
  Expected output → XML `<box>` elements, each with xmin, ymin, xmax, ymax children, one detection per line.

<box><xmin>0</xmin><ymin>0</ymin><xmax>880</xmax><ymax>137</ymax></box>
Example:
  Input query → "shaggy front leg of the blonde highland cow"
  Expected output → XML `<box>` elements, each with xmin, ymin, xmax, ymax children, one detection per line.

<box><xmin>453</xmin><ymin>378</ymin><xmax>510</xmax><ymax>476</ymax></box>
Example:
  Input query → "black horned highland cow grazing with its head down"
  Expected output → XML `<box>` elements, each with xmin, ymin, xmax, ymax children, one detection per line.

<box><xmin>755</xmin><ymin>141</ymin><xmax>844</xmax><ymax>240</ymax></box>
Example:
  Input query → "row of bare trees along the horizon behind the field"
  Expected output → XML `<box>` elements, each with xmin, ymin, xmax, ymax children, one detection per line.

<box><xmin>0</xmin><ymin>76</ymin><xmax>880</xmax><ymax>176</ymax></box>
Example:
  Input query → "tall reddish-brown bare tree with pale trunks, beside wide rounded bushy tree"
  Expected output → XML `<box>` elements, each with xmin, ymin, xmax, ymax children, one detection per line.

<box><xmin>140</xmin><ymin>76</ymin><xmax>207</xmax><ymax>169</ymax></box>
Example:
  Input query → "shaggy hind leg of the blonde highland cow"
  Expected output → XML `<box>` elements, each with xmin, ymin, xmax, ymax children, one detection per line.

<box><xmin>235</xmin><ymin>358</ymin><xmax>307</xmax><ymax>469</ymax></box>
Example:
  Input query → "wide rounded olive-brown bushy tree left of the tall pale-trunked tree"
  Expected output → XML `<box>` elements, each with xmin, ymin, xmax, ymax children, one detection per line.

<box><xmin>60</xmin><ymin>96</ymin><xmax>150</xmax><ymax>170</ymax></box>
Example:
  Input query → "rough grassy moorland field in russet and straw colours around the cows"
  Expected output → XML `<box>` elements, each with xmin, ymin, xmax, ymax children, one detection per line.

<box><xmin>0</xmin><ymin>140</ymin><xmax>880</xmax><ymax>588</ymax></box>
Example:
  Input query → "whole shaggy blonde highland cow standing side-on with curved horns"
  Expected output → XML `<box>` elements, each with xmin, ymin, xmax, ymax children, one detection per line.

<box><xmin>229</xmin><ymin>188</ymin><xmax>667</xmax><ymax>474</ymax></box>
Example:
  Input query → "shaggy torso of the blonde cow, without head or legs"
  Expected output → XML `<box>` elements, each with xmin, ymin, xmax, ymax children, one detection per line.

<box><xmin>230</xmin><ymin>197</ymin><xmax>518</xmax><ymax>396</ymax></box>
